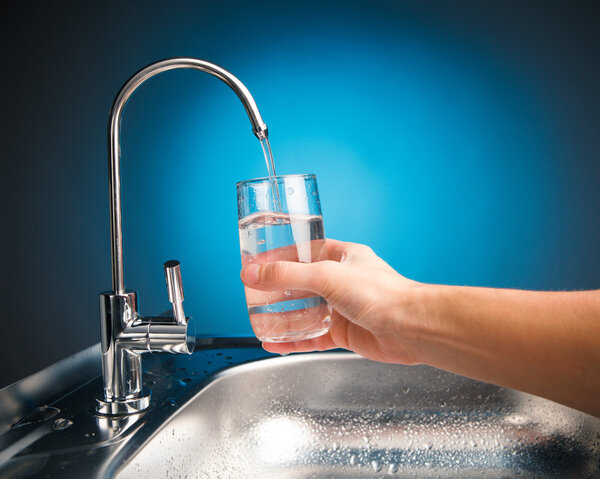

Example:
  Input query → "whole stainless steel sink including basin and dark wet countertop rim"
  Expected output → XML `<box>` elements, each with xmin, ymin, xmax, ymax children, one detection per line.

<box><xmin>0</xmin><ymin>337</ymin><xmax>600</xmax><ymax>479</ymax></box>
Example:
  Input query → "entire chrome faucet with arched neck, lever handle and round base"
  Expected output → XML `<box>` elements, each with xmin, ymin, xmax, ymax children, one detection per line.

<box><xmin>96</xmin><ymin>57</ymin><xmax>268</xmax><ymax>415</ymax></box>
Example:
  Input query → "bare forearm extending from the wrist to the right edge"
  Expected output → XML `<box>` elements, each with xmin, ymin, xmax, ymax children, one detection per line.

<box><xmin>413</xmin><ymin>286</ymin><xmax>600</xmax><ymax>416</ymax></box>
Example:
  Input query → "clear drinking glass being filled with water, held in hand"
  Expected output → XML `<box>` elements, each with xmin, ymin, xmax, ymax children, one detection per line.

<box><xmin>237</xmin><ymin>175</ymin><xmax>331</xmax><ymax>342</ymax></box>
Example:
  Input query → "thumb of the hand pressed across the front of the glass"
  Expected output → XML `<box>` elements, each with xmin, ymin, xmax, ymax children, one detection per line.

<box><xmin>240</xmin><ymin>261</ymin><xmax>328</xmax><ymax>294</ymax></box>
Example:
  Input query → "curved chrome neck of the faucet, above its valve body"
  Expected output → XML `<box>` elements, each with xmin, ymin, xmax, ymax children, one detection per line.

<box><xmin>108</xmin><ymin>57</ymin><xmax>268</xmax><ymax>294</ymax></box>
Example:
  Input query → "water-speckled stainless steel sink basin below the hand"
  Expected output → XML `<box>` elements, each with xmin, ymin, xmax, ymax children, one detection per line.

<box><xmin>116</xmin><ymin>352</ymin><xmax>600</xmax><ymax>479</ymax></box>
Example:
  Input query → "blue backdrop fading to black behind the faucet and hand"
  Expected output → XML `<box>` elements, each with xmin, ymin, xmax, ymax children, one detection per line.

<box><xmin>0</xmin><ymin>0</ymin><xmax>600</xmax><ymax>386</ymax></box>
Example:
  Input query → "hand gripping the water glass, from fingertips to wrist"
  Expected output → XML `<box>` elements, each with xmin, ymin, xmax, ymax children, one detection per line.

<box><xmin>241</xmin><ymin>239</ymin><xmax>422</xmax><ymax>364</ymax></box>
